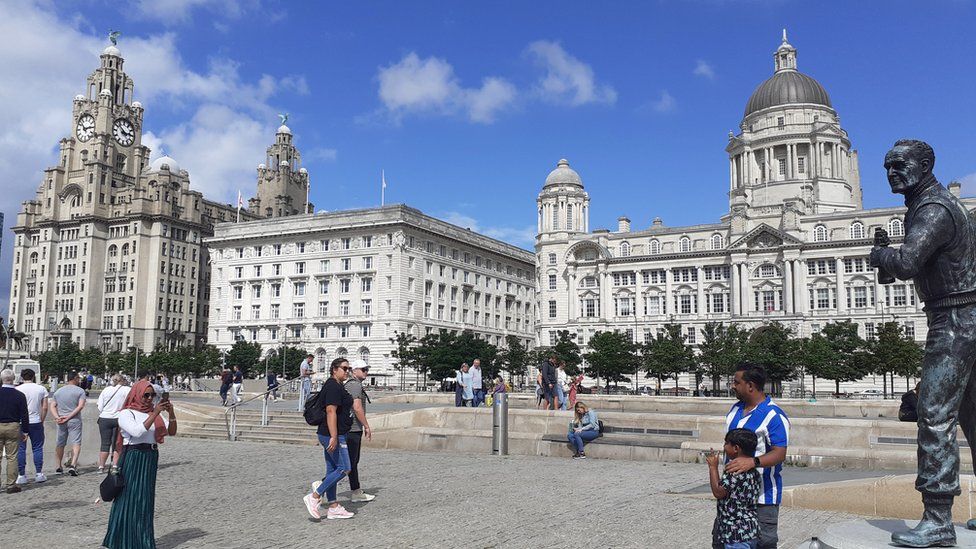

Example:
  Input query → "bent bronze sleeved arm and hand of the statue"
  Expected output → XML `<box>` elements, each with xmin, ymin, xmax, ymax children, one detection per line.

<box><xmin>871</xmin><ymin>204</ymin><xmax>955</xmax><ymax>280</ymax></box>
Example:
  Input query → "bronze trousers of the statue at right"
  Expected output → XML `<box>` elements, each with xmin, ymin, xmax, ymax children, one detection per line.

<box><xmin>915</xmin><ymin>304</ymin><xmax>976</xmax><ymax>499</ymax></box>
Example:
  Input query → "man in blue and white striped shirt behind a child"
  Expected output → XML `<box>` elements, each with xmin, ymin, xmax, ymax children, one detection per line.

<box><xmin>712</xmin><ymin>363</ymin><xmax>790</xmax><ymax>549</ymax></box>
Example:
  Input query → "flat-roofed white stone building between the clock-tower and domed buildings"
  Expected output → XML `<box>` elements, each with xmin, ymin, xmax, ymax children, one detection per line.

<box><xmin>206</xmin><ymin>205</ymin><xmax>535</xmax><ymax>385</ymax></box>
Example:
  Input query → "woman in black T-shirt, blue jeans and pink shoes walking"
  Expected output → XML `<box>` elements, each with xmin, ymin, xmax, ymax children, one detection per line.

<box><xmin>303</xmin><ymin>357</ymin><xmax>354</xmax><ymax>520</ymax></box>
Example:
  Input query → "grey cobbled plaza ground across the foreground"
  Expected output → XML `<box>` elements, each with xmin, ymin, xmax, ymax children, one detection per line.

<box><xmin>0</xmin><ymin>437</ymin><xmax>850</xmax><ymax>549</ymax></box>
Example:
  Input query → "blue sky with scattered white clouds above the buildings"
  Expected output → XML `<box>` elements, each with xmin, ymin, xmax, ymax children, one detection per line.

<box><xmin>0</xmin><ymin>0</ymin><xmax>976</xmax><ymax>316</ymax></box>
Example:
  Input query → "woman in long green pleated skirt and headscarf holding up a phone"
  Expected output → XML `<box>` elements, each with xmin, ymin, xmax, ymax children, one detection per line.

<box><xmin>102</xmin><ymin>381</ymin><xmax>176</xmax><ymax>549</ymax></box>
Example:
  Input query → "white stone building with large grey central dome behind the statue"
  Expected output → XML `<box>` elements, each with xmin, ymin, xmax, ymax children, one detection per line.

<box><xmin>536</xmin><ymin>33</ymin><xmax>976</xmax><ymax>366</ymax></box>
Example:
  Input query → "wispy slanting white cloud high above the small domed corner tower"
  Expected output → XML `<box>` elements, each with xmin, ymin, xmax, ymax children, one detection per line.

<box><xmin>526</xmin><ymin>40</ymin><xmax>617</xmax><ymax>107</ymax></box>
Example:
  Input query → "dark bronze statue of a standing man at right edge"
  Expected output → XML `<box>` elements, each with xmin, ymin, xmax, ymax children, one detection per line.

<box><xmin>871</xmin><ymin>139</ymin><xmax>976</xmax><ymax>547</ymax></box>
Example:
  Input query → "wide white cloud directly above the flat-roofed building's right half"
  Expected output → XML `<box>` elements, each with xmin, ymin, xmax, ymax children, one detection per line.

<box><xmin>377</xmin><ymin>52</ymin><xmax>516</xmax><ymax>124</ymax></box>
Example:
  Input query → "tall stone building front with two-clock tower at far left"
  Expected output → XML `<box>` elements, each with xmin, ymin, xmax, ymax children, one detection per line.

<box><xmin>9</xmin><ymin>42</ymin><xmax>252</xmax><ymax>352</ymax></box>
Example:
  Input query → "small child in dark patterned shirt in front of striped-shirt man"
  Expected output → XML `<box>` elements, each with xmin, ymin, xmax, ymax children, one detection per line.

<box><xmin>705</xmin><ymin>429</ymin><xmax>762</xmax><ymax>549</ymax></box>
